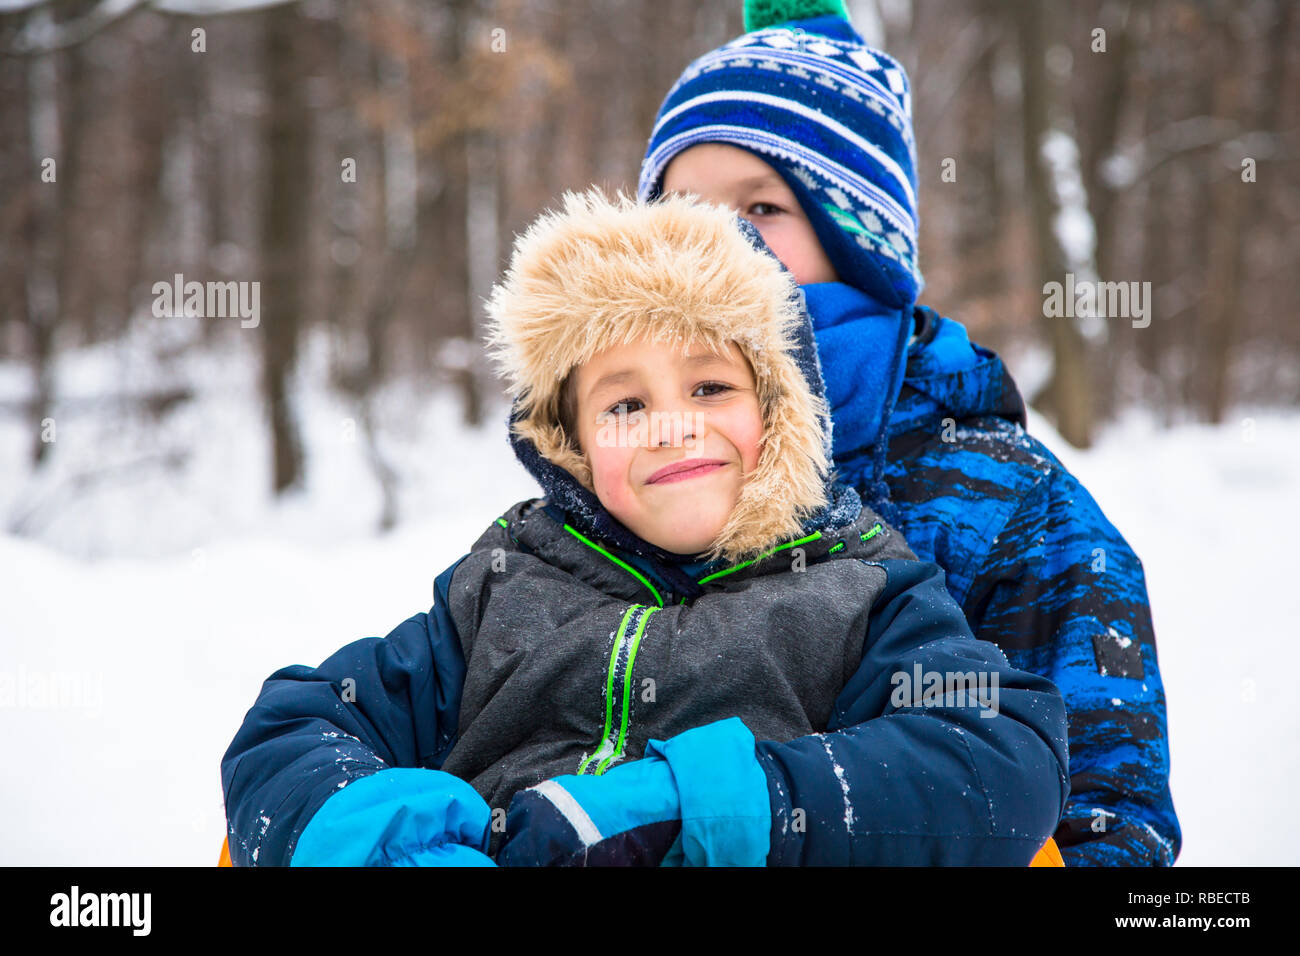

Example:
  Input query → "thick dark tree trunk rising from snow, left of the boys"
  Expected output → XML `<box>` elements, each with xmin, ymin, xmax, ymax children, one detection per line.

<box><xmin>259</xmin><ymin>5</ymin><xmax>309</xmax><ymax>494</ymax></box>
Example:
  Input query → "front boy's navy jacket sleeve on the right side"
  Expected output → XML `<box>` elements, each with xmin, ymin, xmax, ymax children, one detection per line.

<box><xmin>757</xmin><ymin>561</ymin><xmax>1069</xmax><ymax>866</ymax></box>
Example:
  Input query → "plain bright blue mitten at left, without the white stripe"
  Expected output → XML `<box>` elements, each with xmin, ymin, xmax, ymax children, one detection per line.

<box><xmin>289</xmin><ymin>767</ymin><xmax>495</xmax><ymax>866</ymax></box>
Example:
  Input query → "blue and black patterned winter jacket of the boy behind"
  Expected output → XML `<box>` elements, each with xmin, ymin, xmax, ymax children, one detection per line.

<box><xmin>842</xmin><ymin>307</ymin><xmax>1182</xmax><ymax>866</ymax></box>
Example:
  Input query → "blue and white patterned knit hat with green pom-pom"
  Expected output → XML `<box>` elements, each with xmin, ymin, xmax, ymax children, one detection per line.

<box><xmin>637</xmin><ymin>0</ymin><xmax>923</xmax><ymax>310</ymax></box>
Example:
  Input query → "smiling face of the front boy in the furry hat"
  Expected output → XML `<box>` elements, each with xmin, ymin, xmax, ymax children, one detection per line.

<box><xmin>573</xmin><ymin>339</ymin><xmax>763</xmax><ymax>554</ymax></box>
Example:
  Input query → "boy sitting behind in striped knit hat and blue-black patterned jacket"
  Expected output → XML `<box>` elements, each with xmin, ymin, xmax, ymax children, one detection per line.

<box><xmin>638</xmin><ymin>0</ymin><xmax>1182</xmax><ymax>865</ymax></box>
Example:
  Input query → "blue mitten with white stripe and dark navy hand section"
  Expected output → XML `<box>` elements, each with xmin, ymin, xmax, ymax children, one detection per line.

<box><xmin>498</xmin><ymin>717</ymin><xmax>772</xmax><ymax>866</ymax></box>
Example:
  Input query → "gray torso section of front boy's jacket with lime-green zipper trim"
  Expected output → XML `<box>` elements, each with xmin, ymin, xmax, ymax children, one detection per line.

<box><xmin>442</xmin><ymin>493</ymin><xmax>913</xmax><ymax>806</ymax></box>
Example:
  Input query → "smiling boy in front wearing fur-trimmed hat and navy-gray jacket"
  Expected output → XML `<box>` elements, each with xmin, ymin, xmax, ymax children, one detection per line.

<box><xmin>222</xmin><ymin>190</ymin><xmax>1067</xmax><ymax>865</ymax></box>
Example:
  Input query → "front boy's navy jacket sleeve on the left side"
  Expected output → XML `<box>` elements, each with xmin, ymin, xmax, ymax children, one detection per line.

<box><xmin>221</xmin><ymin>562</ymin><xmax>465</xmax><ymax>866</ymax></box>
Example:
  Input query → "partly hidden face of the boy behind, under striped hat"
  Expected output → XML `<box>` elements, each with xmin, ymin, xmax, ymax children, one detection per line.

<box><xmin>663</xmin><ymin>143</ymin><xmax>839</xmax><ymax>285</ymax></box>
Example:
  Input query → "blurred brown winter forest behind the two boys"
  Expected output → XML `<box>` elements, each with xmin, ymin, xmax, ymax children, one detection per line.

<box><xmin>0</xmin><ymin>0</ymin><xmax>1300</xmax><ymax>522</ymax></box>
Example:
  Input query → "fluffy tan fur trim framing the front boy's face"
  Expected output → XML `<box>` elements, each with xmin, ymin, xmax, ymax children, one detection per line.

<box><xmin>488</xmin><ymin>187</ymin><xmax>829</xmax><ymax>561</ymax></box>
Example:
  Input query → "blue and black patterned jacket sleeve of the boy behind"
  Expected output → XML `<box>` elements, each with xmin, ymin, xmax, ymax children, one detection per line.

<box><xmin>966</xmin><ymin>463</ymin><xmax>1182</xmax><ymax>866</ymax></box>
